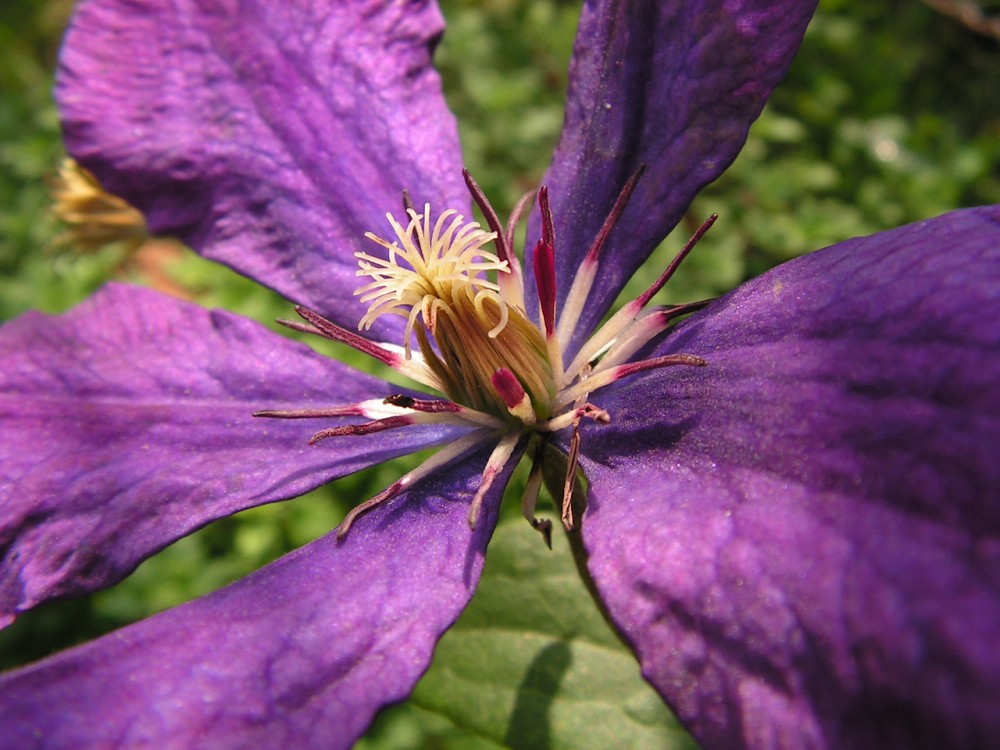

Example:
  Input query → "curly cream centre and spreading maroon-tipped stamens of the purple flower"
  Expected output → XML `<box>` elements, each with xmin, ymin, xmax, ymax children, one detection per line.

<box><xmin>257</xmin><ymin>171</ymin><xmax>715</xmax><ymax>540</ymax></box>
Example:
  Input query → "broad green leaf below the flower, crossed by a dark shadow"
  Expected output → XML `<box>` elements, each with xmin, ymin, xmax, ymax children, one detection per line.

<box><xmin>411</xmin><ymin>521</ymin><xmax>696</xmax><ymax>750</ymax></box>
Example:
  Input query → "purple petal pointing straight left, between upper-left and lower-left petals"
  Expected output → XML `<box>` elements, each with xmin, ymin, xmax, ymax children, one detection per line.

<box><xmin>0</xmin><ymin>286</ymin><xmax>458</xmax><ymax>624</ymax></box>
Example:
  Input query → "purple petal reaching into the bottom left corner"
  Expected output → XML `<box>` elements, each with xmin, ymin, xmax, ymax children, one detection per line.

<box><xmin>0</xmin><ymin>453</ymin><xmax>509</xmax><ymax>750</ymax></box>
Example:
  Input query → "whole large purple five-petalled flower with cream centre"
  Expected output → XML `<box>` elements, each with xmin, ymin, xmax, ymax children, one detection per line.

<box><xmin>0</xmin><ymin>0</ymin><xmax>1000</xmax><ymax>748</ymax></box>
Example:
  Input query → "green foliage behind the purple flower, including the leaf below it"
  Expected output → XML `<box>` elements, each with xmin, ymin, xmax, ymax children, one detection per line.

<box><xmin>0</xmin><ymin>0</ymin><xmax>1000</xmax><ymax>748</ymax></box>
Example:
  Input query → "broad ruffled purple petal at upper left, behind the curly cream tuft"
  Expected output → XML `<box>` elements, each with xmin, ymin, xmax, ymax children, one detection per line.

<box><xmin>58</xmin><ymin>0</ymin><xmax>469</xmax><ymax>340</ymax></box>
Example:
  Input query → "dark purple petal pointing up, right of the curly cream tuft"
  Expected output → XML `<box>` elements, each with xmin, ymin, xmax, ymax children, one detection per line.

<box><xmin>526</xmin><ymin>0</ymin><xmax>816</xmax><ymax>352</ymax></box>
